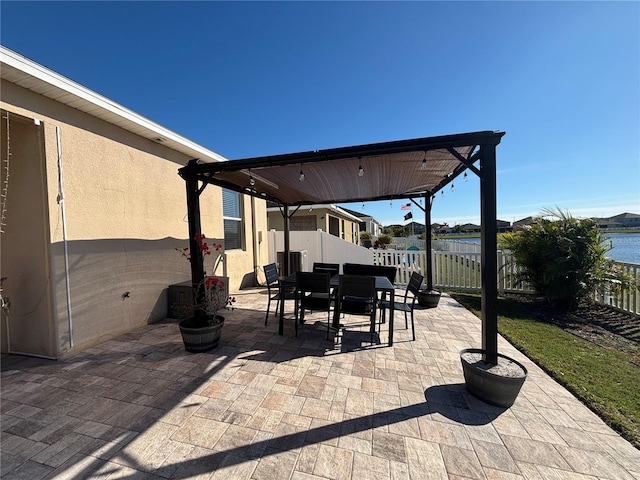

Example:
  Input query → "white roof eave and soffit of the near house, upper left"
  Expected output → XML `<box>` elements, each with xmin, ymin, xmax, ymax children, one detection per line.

<box><xmin>0</xmin><ymin>45</ymin><xmax>227</xmax><ymax>163</ymax></box>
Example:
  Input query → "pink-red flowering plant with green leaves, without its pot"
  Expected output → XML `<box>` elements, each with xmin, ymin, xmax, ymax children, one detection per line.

<box><xmin>173</xmin><ymin>233</ymin><xmax>236</xmax><ymax>327</ymax></box>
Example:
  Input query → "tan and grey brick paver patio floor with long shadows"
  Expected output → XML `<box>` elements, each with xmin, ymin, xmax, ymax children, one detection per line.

<box><xmin>1</xmin><ymin>290</ymin><xmax>640</xmax><ymax>480</ymax></box>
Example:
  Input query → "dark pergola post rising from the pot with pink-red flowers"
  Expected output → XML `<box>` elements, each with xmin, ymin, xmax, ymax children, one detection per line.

<box><xmin>185</xmin><ymin>172</ymin><xmax>207</xmax><ymax>321</ymax></box>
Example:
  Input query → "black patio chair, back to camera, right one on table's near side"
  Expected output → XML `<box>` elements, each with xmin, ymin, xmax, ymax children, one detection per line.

<box><xmin>327</xmin><ymin>275</ymin><xmax>378</xmax><ymax>343</ymax></box>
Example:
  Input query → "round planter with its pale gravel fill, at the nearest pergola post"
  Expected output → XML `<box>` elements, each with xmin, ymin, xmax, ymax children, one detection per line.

<box><xmin>460</xmin><ymin>348</ymin><xmax>527</xmax><ymax>408</ymax></box>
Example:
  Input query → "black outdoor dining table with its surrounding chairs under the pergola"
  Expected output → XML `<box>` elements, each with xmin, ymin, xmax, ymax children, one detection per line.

<box><xmin>263</xmin><ymin>263</ymin><xmax>424</xmax><ymax>346</ymax></box>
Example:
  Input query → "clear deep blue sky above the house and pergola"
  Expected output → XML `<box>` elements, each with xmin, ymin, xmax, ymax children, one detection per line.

<box><xmin>0</xmin><ymin>0</ymin><xmax>640</xmax><ymax>225</ymax></box>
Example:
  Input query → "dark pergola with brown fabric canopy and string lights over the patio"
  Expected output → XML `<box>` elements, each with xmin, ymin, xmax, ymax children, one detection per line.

<box><xmin>179</xmin><ymin>131</ymin><xmax>504</xmax><ymax>364</ymax></box>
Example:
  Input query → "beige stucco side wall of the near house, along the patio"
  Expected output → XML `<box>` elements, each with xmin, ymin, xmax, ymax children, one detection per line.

<box><xmin>2</xmin><ymin>82</ymin><xmax>267</xmax><ymax>356</ymax></box>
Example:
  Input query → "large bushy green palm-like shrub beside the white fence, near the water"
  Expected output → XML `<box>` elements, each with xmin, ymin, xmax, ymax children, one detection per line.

<box><xmin>498</xmin><ymin>209</ymin><xmax>631</xmax><ymax>311</ymax></box>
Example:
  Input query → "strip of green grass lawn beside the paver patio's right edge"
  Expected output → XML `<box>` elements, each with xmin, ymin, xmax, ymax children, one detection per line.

<box><xmin>448</xmin><ymin>292</ymin><xmax>640</xmax><ymax>448</ymax></box>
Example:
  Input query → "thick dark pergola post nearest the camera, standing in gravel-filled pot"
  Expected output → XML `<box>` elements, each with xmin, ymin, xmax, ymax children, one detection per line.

<box><xmin>480</xmin><ymin>144</ymin><xmax>498</xmax><ymax>365</ymax></box>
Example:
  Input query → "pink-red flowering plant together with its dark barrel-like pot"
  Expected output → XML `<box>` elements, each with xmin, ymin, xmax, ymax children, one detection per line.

<box><xmin>174</xmin><ymin>233</ymin><xmax>235</xmax><ymax>353</ymax></box>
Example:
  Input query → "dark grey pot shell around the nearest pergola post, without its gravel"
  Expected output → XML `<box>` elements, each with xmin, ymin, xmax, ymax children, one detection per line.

<box><xmin>460</xmin><ymin>348</ymin><xmax>528</xmax><ymax>408</ymax></box>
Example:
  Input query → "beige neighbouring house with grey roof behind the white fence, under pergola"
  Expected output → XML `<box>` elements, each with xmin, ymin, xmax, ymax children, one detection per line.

<box><xmin>267</xmin><ymin>203</ymin><xmax>360</xmax><ymax>245</ymax></box>
